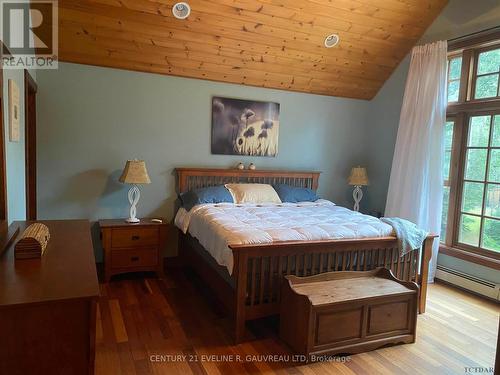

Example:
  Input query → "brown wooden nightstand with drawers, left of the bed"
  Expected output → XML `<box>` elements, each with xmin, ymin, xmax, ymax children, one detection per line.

<box><xmin>99</xmin><ymin>219</ymin><xmax>168</xmax><ymax>282</ymax></box>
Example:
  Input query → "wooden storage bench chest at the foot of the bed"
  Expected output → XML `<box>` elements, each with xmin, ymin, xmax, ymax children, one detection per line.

<box><xmin>280</xmin><ymin>268</ymin><xmax>418</xmax><ymax>357</ymax></box>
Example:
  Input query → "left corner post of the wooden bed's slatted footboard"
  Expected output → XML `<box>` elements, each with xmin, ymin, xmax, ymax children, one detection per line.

<box><xmin>233</xmin><ymin>250</ymin><xmax>248</xmax><ymax>344</ymax></box>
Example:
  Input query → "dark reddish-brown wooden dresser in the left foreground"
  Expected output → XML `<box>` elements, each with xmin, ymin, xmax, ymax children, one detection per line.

<box><xmin>0</xmin><ymin>221</ymin><xmax>99</xmax><ymax>375</ymax></box>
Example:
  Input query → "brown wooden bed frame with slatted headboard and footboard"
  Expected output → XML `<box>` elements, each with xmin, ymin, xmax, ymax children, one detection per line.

<box><xmin>176</xmin><ymin>168</ymin><xmax>436</xmax><ymax>342</ymax></box>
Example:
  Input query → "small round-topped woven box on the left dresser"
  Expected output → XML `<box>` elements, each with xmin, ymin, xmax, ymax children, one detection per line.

<box><xmin>14</xmin><ymin>223</ymin><xmax>50</xmax><ymax>259</ymax></box>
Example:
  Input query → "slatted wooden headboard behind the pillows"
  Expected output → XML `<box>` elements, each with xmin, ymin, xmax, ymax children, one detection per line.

<box><xmin>175</xmin><ymin>168</ymin><xmax>321</xmax><ymax>194</ymax></box>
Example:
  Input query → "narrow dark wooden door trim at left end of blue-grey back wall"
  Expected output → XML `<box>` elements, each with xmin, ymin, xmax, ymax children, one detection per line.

<box><xmin>24</xmin><ymin>69</ymin><xmax>38</xmax><ymax>220</ymax></box>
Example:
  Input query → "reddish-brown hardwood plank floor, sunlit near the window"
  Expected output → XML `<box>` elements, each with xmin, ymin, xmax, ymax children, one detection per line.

<box><xmin>96</xmin><ymin>269</ymin><xmax>500</xmax><ymax>375</ymax></box>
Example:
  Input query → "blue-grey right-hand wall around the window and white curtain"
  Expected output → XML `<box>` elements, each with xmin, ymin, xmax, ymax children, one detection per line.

<box><xmin>366</xmin><ymin>0</ymin><xmax>500</xmax><ymax>283</ymax></box>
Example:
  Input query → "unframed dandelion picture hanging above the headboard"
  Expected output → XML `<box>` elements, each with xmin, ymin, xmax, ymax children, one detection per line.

<box><xmin>212</xmin><ymin>97</ymin><xmax>280</xmax><ymax>156</ymax></box>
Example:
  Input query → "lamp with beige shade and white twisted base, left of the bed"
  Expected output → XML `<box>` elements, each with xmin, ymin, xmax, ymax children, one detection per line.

<box><xmin>120</xmin><ymin>159</ymin><xmax>151</xmax><ymax>223</ymax></box>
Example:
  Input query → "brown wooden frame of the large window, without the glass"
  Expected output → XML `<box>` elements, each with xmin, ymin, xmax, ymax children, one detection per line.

<box><xmin>440</xmin><ymin>29</ymin><xmax>500</xmax><ymax>270</ymax></box>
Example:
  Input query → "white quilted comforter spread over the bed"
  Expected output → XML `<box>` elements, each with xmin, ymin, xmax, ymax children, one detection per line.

<box><xmin>175</xmin><ymin>199</ymin><xmax>393</xmax><ymax>274</ymax></box>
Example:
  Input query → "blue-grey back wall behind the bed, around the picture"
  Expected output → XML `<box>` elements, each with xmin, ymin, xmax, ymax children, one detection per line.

<box><xmin>37</xmin><ymin>63</ymin><xmax>369</xmax><ymax>257</ymax></box>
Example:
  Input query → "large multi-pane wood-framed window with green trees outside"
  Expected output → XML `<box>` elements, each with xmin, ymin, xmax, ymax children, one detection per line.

<box><xmin>440</xmin><ymin>32</ymin><xmax>500</xmax><ymax>260</ymax></box>
